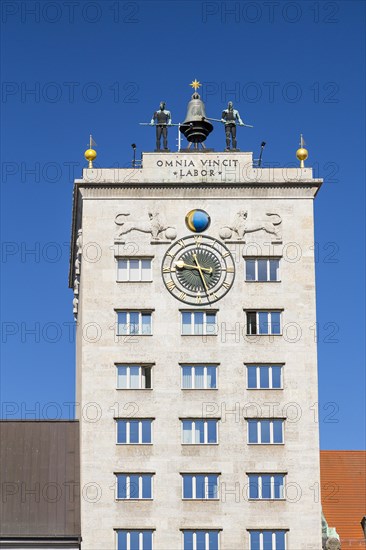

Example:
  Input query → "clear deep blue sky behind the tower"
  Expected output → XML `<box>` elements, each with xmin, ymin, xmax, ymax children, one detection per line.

<box><xmin>1</xmin><ymin>0</ymin><xmax>366</xmax><ymax>449</ymax></box>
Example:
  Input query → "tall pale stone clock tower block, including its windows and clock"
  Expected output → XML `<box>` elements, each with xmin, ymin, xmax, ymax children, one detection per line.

<box><xmin>70</xmin><ymin>128</ymin><xmax>321</xmax><ymax>550</ymax></box>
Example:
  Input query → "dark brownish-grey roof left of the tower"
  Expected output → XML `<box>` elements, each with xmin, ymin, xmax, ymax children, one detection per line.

<box><xmin>0</xmin><ymin>420</ymin><xmax>80</xmax><ymax>540</ymax></box>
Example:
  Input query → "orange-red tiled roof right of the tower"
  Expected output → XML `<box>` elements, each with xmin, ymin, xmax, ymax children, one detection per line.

<box><xmin>320</xmin><ymin>451</ymin><xmax>366</xmax><ymax>550</ymax></box>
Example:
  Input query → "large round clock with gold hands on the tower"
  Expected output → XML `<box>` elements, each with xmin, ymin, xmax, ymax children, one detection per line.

<box><xmin>162</xmin><ymin>235</ymin><xmax>235</xmax><ymax>305</ymax></box>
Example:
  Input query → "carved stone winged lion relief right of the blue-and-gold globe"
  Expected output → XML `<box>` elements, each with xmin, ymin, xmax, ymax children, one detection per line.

<box><xmin>219</xmin><ymin>210</ymin><xmax>282</xmax><ymax>241</ymax></box>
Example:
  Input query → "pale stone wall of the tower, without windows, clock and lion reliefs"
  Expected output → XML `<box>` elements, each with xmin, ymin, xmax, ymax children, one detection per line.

<box><xmin>70</xmin><ymin>152</ymin><xmax>322</xmax><ymax>550</ymax></box>
